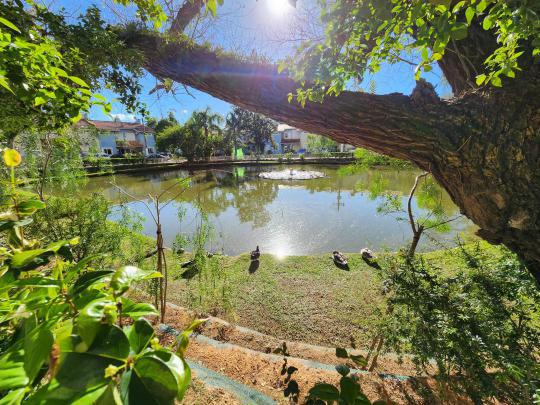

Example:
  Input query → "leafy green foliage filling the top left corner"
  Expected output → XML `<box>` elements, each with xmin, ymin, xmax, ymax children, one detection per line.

<box><xmin>0</xmin><ymin>0</ymin><xmax>165</xmax><ymax>142</ymax></box>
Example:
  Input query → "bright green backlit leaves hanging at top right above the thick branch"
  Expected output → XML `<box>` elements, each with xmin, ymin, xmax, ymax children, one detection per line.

<box><xmin>281</xmin><ymin>0</ymin><xmax>540</xmax><ymax>104</ymax></box>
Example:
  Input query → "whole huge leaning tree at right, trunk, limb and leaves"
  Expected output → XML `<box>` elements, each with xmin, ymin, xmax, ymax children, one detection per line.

<box><xmin>119</xmin><ymin>0</ymin><xmax>540</xmax><ymax>280</ymax></box>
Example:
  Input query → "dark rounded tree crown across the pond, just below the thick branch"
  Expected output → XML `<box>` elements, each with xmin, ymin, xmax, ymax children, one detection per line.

<box><xmin>226</xmin><ymin>107</ymin><xmax>277</xmax><ymax>154</ymax></box>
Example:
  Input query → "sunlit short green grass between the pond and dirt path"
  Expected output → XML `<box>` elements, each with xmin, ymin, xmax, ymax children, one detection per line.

<box><xmin>155</xmin><ymin>243</ymin><xmax>498</xmax><ymax>348</ymax></box>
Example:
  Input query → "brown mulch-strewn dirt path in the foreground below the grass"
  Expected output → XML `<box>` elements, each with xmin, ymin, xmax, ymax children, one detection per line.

<box><xmin>161</xmin><ymin>306</ymin><xmax>468</xmax><ymax>404</ymax></box>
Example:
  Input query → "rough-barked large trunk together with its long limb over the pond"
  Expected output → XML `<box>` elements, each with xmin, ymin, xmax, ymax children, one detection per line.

<box><xmin>125</xmin><ymin>32</ymin><xmax>540</xmax><ymax>280</ymax></box>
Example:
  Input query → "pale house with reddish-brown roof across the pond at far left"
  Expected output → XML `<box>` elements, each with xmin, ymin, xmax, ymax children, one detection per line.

<box><xmin>75</xmin><ymin>118</ymin><xmax>156</xmax><ymax>156</ymax></box>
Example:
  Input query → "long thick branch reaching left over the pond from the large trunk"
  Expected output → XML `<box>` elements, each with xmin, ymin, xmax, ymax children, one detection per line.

<box><xmin>125</xmin><ymin>33</ymin><xmax>460</xmax><ymax>170</ymax></box>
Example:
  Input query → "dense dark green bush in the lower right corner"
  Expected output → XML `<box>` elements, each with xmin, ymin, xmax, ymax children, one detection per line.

<box><xmin>383</xmin><ymin>246</ymin><xmax>540</xmax><ymax>404</ymax></box>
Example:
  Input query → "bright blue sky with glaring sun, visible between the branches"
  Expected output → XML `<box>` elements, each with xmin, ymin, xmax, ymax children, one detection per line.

<box><xmin>52</xmin><ymin>0</ymin><xmax>450</xmax><ymax>121</ymax></box>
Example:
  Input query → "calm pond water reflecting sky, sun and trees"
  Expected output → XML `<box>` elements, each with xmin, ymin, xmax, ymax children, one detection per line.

<box><xmin>75</xmin><ymin>165</ymin><xmax>473</xmax><ymax>252</ymax></box>
